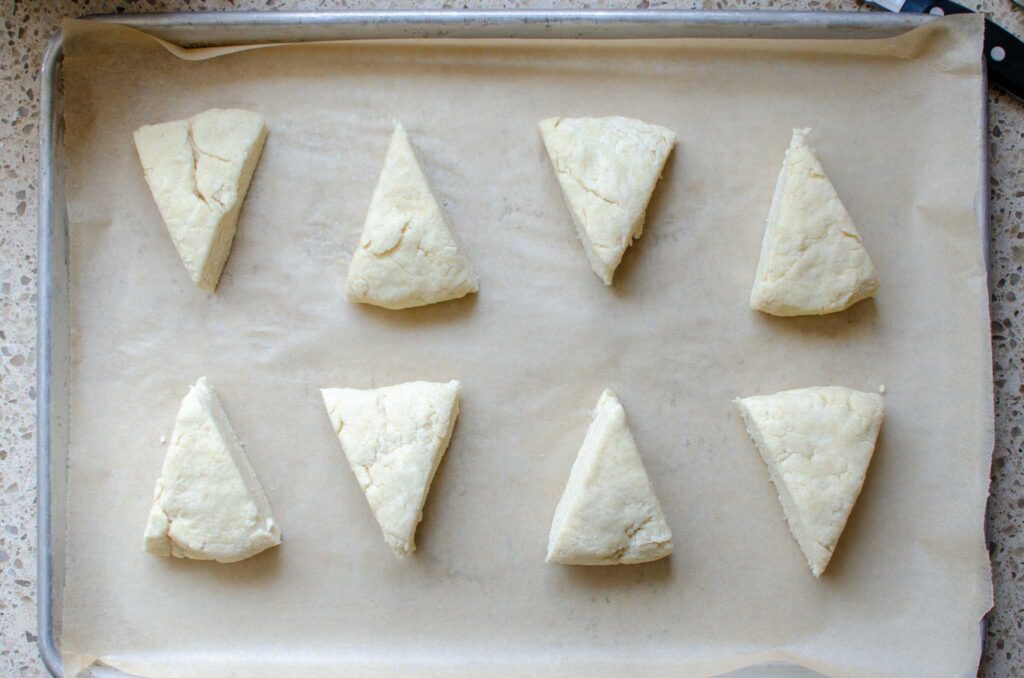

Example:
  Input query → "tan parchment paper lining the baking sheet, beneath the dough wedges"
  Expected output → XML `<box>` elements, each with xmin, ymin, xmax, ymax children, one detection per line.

<box><xmin>61</xmin><ymin>16</ymin><xmax>992</xmax><ymax>676</ymax></box>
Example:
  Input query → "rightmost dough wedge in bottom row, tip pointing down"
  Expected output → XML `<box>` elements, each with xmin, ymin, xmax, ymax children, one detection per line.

<box><xmin>735</xmin><ymin>386</ymin><xmax>884</xmax><ymax>577</ymax></box>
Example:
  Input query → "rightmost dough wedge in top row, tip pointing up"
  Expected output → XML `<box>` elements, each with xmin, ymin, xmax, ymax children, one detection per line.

<box><xmin>751</xmin><ymin>129</ymin><xmax>879</xmax><ymax>315</ymax></box>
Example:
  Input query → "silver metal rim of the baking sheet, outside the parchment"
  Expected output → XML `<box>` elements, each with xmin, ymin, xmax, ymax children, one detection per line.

<box><xmin>36</xmin><ymin>10</ymin><xmax>990</xmax><ymax>678</ymax></box>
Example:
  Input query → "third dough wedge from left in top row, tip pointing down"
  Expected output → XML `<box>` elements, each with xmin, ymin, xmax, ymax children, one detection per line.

<box><xmin>540</xmin><ymin>117</ymin><xmax>676</xmax><ymax>285</ymax></box>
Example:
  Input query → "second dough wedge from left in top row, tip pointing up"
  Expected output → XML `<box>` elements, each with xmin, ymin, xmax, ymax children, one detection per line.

<box><xmin>347</xmin><ymin>123</ymin><xmax>478</xmax><ymax>308</ymax></box>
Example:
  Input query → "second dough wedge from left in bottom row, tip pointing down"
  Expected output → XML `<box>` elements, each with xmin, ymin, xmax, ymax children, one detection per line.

<box><xmin>321</xmin><ymin>381</ymin><xmax>459</xmax><ymax>558</ymax></box>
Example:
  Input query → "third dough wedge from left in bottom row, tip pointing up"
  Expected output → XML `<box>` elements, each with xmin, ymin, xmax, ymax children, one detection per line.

<box><xmin>548</xmin><ymin>390</ymin><xmax>672</xmax><ymax>565</ymax></box>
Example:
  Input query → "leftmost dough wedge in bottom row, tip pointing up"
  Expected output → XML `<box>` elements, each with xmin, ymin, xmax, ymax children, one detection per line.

<box><xmin>144</xmin><ymin>378</ymin><xmax>281</xmax><ymax>562</ymax></box>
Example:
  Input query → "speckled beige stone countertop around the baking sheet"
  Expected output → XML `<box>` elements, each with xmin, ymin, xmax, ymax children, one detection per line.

<box><xmin>0</xmin><ymin>0</ymin><xmax>1024</xmax><ymax>676</ymax></box>
